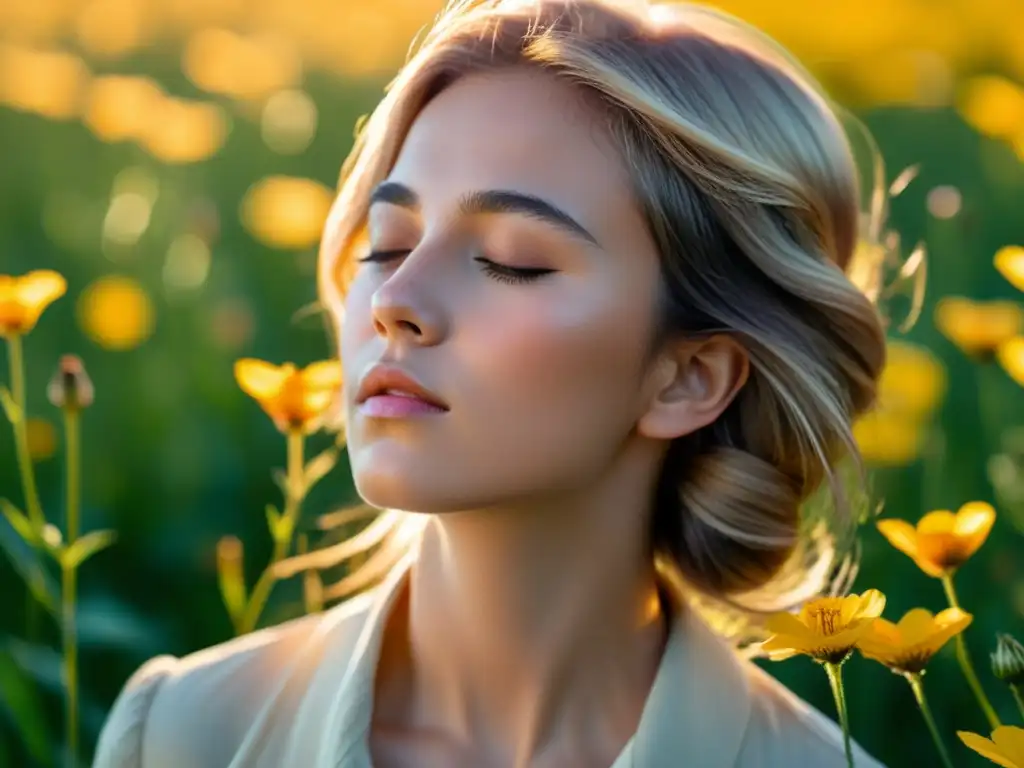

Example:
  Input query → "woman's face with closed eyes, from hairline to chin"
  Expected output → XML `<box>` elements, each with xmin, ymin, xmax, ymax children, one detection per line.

<box><xmin>341</xmin><ymin>70</ymin><xmax>659</xmax><ymax>513</ymax></box>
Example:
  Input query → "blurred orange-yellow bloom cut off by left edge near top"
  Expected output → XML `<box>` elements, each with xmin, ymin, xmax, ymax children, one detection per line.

<box><xmin>0</xmin><ymin>43</ymin><xmax>90</xmax><ymax>120</ymax></box>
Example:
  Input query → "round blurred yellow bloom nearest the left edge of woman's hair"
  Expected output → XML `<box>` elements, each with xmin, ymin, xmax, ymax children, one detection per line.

<box><xmin>242</xmin><ymin>176</ymin><xmax>334</xmax><ymax>249</ymax></box>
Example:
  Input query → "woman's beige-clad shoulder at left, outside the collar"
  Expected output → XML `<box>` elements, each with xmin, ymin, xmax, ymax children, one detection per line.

<box><xmin>94</xmin><ymin>594</ymin><xmax>372</xmax><ymax>768</ymax></box>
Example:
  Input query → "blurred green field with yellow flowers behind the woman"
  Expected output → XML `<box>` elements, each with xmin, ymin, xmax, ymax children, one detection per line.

<box><xmin>0</xmin><ymin>0</ymin><xmax>1024</xmax><ymax>767</ymax></box>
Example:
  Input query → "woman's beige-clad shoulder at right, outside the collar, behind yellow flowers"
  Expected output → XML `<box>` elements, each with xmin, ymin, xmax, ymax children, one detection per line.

<box><xmin>740</xmin><ymin>663</ymin><xmax>885</xmax><ymax>768</ymax></box>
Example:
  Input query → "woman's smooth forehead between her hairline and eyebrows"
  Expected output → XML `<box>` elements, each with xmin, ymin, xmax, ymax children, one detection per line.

<box><xmin>389</xmin><ymin>69</ymin><xmax>642</xmax><ymax>244</ymax></box>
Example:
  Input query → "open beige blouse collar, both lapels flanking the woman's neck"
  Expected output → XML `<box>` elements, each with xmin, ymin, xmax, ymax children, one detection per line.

<box><xmin>317</xmin><ymin>557</ymin><xmax>751</xmax><ymax>768</ymax></box>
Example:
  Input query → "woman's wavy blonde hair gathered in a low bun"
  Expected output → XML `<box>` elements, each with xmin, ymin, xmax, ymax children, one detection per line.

<box><xmin>280</xmin><ymin>0</ymin><xmax>886</xmax><ymax>637</ymax></box>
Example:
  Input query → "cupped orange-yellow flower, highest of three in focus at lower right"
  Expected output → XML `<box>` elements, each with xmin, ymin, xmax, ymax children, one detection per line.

<box><xmin>878</xmin><ymin>502</ymin><xmax>995</xmax><ymax>579</ymax></box>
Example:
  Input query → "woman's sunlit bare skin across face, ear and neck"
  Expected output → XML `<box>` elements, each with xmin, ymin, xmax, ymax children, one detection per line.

<box><xmin>327</xmin><ymin>71</ymin><xmax>746</xmax><ymax>764</ymax></box>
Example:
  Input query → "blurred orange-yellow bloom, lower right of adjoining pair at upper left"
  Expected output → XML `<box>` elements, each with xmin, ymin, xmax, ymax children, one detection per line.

<box><xmin>140</xmin><ymin>97</ymin><xmax>227</xmax><ymax>163</ymax></box>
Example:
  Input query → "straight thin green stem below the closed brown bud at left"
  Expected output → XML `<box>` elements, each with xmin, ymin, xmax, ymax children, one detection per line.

<box><xmin>60</xmin><ymin>408</ymin><xmax>82</xmax><ymax>767</ymax></box>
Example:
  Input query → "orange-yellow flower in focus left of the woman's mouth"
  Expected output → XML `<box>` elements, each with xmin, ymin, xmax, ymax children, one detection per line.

<box><xmin>234</xmin><ymin>358</ymin><xmax>341</xmax><ymax>433</ymax></box>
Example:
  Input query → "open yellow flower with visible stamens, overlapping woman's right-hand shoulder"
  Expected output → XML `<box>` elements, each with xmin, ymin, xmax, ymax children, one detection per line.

<box><xmin>761</xmin><ymin>590</ymin><xmax>886</xmax><ymax>664</ymax></box>
